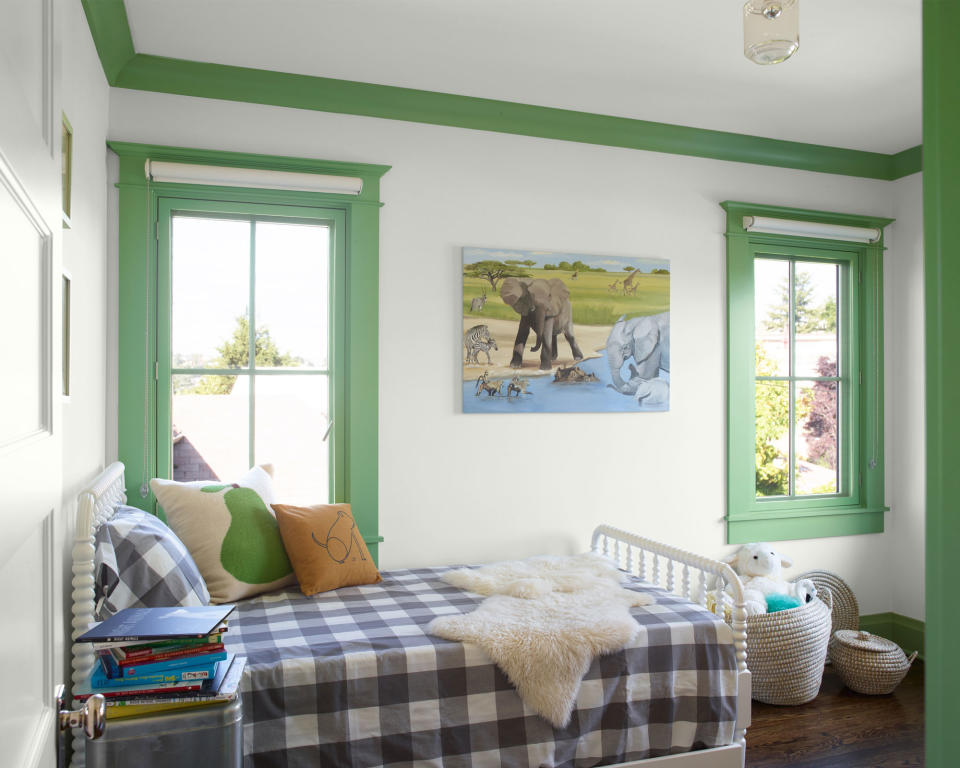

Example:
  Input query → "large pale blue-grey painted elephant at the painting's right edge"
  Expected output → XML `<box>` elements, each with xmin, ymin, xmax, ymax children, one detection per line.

<box><xmin>606</xmin><ymin>312</ymin><xmax>670</xmax><ymax>395</ymax></box>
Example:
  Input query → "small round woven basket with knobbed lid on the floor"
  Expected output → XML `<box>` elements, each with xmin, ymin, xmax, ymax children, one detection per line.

<box><xmin>830</xmin><ymin>629</ymin><xmax>917</xmax><ymax>695</ymax></box>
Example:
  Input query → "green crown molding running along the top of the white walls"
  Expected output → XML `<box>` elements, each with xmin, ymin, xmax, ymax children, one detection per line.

<box><xmin>83</xmin><ymin>0</ymin><xmax>920</xmax><ymax>181</ymax></box>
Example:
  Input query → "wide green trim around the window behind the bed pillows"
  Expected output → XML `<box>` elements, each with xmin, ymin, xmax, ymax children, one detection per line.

<box><xmin>114</xmin><ymin>142</ymin><xmax>390</xmax><ymax>560</ymax></box>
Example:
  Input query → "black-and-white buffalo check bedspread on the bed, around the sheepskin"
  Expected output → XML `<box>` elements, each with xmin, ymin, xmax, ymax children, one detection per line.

<box><xmin>226</xmin><ymin>568</ymin><xmax>737</xmax><ymax>768</ymax></box>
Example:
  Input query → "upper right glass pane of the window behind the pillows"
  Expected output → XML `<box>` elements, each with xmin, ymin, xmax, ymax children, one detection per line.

<box><xmin>256</xmin><ymin>222</ymin><xmax>330</xmax><ymax>369</ymax></box>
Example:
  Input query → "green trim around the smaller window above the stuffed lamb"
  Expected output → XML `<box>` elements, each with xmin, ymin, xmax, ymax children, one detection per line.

<box><xmin>721</xmin><ymin>201</ymin><xmax>892</xmax><ymax>544</ymax></box>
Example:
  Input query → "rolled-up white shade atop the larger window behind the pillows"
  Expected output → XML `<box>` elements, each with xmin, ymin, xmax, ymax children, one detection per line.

<box><xmin>145</xmin><ymin>160</ymin><xmax>363</xmax><ymax>195</ymax></box>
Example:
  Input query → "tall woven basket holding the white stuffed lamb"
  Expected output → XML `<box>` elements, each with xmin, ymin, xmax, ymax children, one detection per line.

<box><xmin>747</xmin><ymin>588</ymin><xmax>833</xmax><ymax>705</ymax></box>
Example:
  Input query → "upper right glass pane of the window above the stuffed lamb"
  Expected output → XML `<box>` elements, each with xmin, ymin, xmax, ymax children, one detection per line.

<box><xmin>793</xmin><ymin>261</ymin><xmax>840</xmax><ymax>377</ymax></box>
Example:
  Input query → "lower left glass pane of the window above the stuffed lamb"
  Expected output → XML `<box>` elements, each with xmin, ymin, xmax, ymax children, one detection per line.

<box><xmin>756</xmin><ymin>381</ymin><xmax>790</xmax><ymax>497</ymax></box>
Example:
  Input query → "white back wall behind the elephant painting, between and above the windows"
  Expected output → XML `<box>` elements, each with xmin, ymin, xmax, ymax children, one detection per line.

<box><xmin>110</xmin><ymin>89</ymin><xmax>920</xmax><ymax>613</ymax></box>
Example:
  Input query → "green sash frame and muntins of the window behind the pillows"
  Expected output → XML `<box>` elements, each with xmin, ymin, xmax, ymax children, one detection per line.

<box><xmin>156</xmin><ymin>196</ymin><xmax>346</xmax><ymax>502</ymax></box>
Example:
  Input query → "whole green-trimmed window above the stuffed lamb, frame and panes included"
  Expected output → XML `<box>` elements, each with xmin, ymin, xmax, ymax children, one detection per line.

<box><xmin>723</xmin><ymin>202</ymin><xmax>889</xmax><ymax>543</ymax></box>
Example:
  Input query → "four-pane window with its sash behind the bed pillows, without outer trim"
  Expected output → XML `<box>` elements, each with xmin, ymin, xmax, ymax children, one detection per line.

<box><xmin>163</xmin><ymin>204</ymin><xmax>343</xmax><ymax>504</ymax></box>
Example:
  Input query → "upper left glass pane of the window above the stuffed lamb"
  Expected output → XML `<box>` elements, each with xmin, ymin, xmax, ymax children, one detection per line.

<box><xmin>753</xmin><ymin>259</ymin><xmax>790</xmax><ymax>376</ymax></box>
